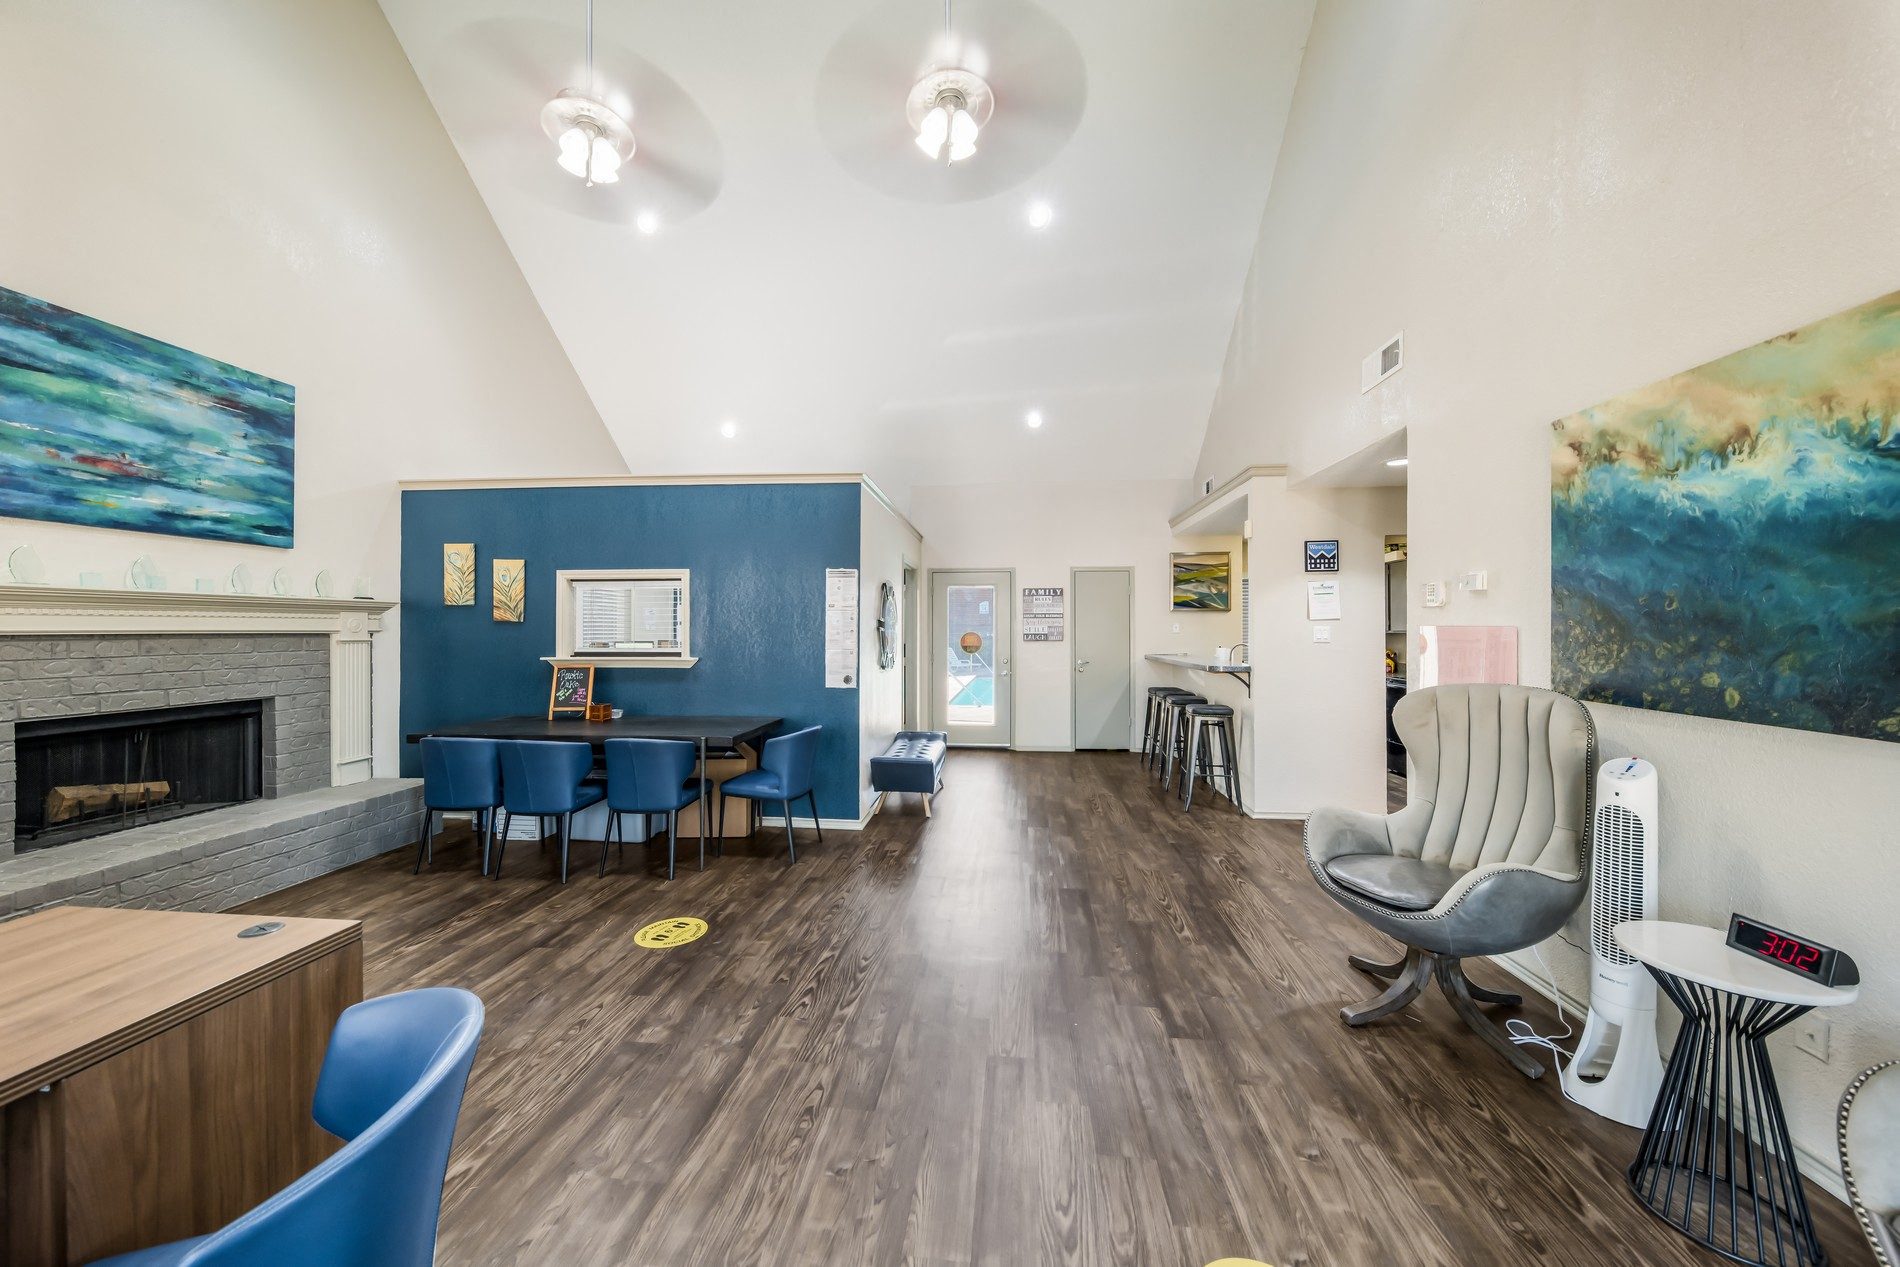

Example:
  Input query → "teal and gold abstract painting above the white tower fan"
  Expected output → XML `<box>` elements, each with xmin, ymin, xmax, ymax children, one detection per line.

<box><xmin>1550</xmin><ymin>293</ymin><xmax>1900</xmax><ymax>741</ymax></box>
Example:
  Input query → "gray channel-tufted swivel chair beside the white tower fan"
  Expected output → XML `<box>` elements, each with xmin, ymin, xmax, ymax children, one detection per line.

<box><xmin>1305</xmin><ymin>686</ymin><xmax>1596</xmax><ymax>1077</ymax></box>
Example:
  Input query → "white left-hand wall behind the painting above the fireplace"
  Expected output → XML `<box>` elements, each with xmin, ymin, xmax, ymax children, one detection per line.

<box><xmin>0</xmin><ymin>0</ymin><xmax>625</xmax><ymax>775</ymax></box>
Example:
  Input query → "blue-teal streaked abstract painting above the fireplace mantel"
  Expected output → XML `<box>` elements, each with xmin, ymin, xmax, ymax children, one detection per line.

<box><xmin>0</xmin><ymin>287</ymin><xmax>296</xmax><ymax>547</ymax></box>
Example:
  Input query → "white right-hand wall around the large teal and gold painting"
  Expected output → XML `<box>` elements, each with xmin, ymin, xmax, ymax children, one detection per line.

<box><xmin>1201</xmin><ymin>0</ymin><xmax>1900</xmax><ymax>1192</ymax></box>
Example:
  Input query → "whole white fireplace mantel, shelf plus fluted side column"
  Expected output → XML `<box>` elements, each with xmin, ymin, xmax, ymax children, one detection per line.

<box><xmin>0</xmin><ymin>585</ymin><xmax>395</xmax><ymax>785</ymax></box>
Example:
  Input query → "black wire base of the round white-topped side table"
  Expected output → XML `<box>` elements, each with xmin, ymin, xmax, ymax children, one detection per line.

<box><xmin>1630</xmin><ymin>967</ymin><xmax>1828</xmax><ymax>1267</ymax></box>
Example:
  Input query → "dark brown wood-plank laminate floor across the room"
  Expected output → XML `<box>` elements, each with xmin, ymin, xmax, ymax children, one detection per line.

<box><xmin>253</xmin><ymin>752</ymin><xmax>1872</xmax><ymax>1267</ymax></box>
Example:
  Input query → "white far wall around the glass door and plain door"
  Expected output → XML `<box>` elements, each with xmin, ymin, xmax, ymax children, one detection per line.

<box><xmin>910</xmin><ymin>481</ymin><xmax>1241</xmax><ymax>750</ymax></box>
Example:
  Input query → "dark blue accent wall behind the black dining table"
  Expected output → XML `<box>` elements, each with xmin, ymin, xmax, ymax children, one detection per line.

<box><xmin>401</xmin><ymin>482</ymin><xmax>861</xmax><ymax>821</ymax></box>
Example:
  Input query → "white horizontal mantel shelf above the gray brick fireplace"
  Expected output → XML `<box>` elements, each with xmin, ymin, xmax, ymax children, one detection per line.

<box><xmin>0</xmin><ymin>585</ymin><xmax>395</xmax><ymax>638</ymax></box>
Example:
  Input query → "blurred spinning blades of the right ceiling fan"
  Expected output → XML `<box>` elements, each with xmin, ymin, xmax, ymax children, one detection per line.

<box><xmin>815</xmin><ymin>0</ymin><xmax>1089</xmax><ymax>203</ymax></box>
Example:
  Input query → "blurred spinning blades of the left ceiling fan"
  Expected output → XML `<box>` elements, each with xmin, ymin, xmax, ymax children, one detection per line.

<box><xmin>429</xmin><ymin>19</ymin><xmax>726</xmax><ymax>224</ymax></box>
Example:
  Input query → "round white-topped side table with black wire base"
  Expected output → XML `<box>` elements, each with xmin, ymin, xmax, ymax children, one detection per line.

<box><xmin>1615</xmin><ymin>919</ymin><xmax>1860</xmax><ymax>1267</ymax></box>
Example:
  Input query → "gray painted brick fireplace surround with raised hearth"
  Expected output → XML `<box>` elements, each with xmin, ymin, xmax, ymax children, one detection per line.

<box><xmin>0</xmin><ymin>587</ymin><xmax>420</xmax><ymax>919</ymax></box>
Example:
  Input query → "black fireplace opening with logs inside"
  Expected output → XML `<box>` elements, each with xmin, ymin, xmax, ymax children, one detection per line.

<box><xmin>13</xmin><ymin>699</ymin><xmax>264</xmax><ymax>851</ymax></box>
